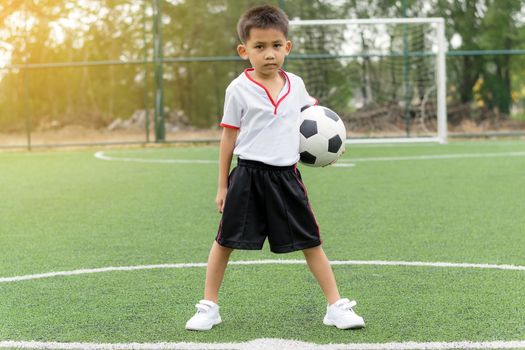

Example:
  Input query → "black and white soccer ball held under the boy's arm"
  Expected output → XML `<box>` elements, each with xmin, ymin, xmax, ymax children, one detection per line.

<box><xmin>299</xmin><ymin>106</ymin><xmax>346</xmax><ymax>167</ymax></box>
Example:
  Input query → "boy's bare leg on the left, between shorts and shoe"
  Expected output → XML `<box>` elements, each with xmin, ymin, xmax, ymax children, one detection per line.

<box><xmin>204</xmin><ymin>241</ymin><xmax>233</xmax><ymax>304</ymax></box>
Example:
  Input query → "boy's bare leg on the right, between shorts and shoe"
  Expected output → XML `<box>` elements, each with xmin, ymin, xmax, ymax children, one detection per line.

<box><xmin>303</xmin><ymin>246</ymin><xmax>341</xmax><ymax>304</ymax></box>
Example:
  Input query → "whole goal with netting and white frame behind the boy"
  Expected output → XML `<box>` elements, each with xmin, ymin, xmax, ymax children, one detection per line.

<box><xmin>285</xmin><ymin>18</ymin><xmax>447</xmax><ymax>143</ymax></box>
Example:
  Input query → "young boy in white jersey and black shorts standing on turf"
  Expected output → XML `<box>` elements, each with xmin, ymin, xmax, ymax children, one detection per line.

<box><xmin>186</xmin><ymin>6</ymin><xmax>365</xmax><ymax>331</ymax></box>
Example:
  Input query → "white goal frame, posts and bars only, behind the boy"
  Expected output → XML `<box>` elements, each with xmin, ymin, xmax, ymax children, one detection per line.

<box><xmin>290</xmin><ymin>17</ymin><xmax>447</xmax><ymax>144</ymax></box>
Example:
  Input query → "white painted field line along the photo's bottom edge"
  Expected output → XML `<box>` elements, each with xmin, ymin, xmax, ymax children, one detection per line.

<box><xmin>0</xmin><ymin>339</ymin><xmax>525</xmax><ymax>350</ymax></box>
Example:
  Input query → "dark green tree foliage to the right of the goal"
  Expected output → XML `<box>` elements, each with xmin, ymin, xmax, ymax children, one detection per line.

<box><xmin>435</xmin><ymin>0</ymin><xmax>524</xmax><ymax>115</ymax></box>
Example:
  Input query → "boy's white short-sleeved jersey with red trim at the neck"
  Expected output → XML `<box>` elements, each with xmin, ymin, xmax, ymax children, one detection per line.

<box><xmin>220</xmin><ymin>68</ymin><xmax>317</xmax><ymax>166</ymax></box>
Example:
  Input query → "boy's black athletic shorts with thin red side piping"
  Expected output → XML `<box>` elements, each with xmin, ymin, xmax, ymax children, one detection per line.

<box><xmin>216</xmin><ymin>159</ymin><xmax>321</xmax><ymax>253</ymax></box>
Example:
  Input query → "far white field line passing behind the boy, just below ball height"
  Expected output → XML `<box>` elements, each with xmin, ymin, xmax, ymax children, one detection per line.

<box><xmin>95</xmin><ymin>151</ymin><xmax>525</xmax><ymax>167</ymax></box>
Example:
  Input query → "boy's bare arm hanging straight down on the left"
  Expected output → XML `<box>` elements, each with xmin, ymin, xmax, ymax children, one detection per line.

<box><xmin>215</xmin><ymin>128</ymin><xmax>239</xmax><ymax>213</ymax></box>
